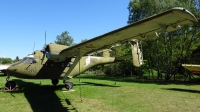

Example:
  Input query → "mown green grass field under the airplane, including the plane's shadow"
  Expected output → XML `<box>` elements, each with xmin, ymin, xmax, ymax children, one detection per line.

<box><xmin>0</xmin><ymin>74</ymin><xmax>200</xmax><ymax>112</ymax></box>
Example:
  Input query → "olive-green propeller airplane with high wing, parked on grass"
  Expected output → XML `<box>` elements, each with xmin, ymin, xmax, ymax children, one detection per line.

<box><xmin>4</xmin><ymin>7</ymin><xmax>198</xmax><ymax>90</ymax></box>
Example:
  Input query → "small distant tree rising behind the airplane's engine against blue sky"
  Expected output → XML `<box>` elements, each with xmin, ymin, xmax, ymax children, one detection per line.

<box><xmin>55</xmin><ymin>31</ymin><xmax>74</xmax><ymax>46</ymax></box>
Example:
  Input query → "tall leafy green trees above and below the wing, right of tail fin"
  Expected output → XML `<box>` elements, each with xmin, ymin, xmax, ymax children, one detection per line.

<box><xmin>127</xmin><ymin>0</ymin><xmax>200</xmax><ymax>79</ymax></box>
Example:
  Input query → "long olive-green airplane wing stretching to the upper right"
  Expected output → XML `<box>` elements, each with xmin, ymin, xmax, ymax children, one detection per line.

<box><xmin>59</xmin><ymin>7</ymin><xmax>198</xmax><ymax>60</ymax></box>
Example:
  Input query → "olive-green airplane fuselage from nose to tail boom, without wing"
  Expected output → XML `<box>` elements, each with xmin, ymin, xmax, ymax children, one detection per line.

<box><xmin>7</xmin><ymin>51</ymin><xmax>115</xmax><ymax>79</ymax></box>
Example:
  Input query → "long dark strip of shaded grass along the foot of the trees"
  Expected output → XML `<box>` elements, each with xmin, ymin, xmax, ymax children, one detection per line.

<box><xmin>77</xmin><ymin>75</ymin><xmax>200</xmax><ymax>86</ymax></box>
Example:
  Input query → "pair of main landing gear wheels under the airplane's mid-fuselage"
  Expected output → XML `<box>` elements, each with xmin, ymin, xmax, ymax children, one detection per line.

<box><xmin>51</xmin><ymin>79</ymin><xmax>73</xmax><ymax>91</ymax></box>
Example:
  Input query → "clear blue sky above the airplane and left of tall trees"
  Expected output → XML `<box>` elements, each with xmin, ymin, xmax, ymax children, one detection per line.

<box><xmin>0</xmin><ymin>0</ymin><xmax>130</xmax><ymax>59</ymax></box>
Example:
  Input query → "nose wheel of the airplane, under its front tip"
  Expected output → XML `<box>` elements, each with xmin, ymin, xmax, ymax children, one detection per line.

<box><xmin>3</xmin><ymin>76</ymin><xmax>18</xmax><ymax>91</ymax></box>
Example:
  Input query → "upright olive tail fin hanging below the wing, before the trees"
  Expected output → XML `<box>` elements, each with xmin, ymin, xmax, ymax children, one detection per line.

<box><xmin>131</xmin><ymin>39</ymin><xmax>143</xmax><ymax>67</ymax></box>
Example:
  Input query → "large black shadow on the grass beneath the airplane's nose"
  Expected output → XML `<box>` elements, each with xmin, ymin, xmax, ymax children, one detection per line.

<box><xmin>12</xmin><ymin>79</ymin><xmax>77</xmax><ymax>112</ymax></box>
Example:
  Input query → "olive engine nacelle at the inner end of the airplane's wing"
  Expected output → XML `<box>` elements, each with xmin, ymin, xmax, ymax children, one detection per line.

<box><xmin>45</xmin><ymin>43</ymin><xmax>69</xmax><ymax>61</ymax></box>
